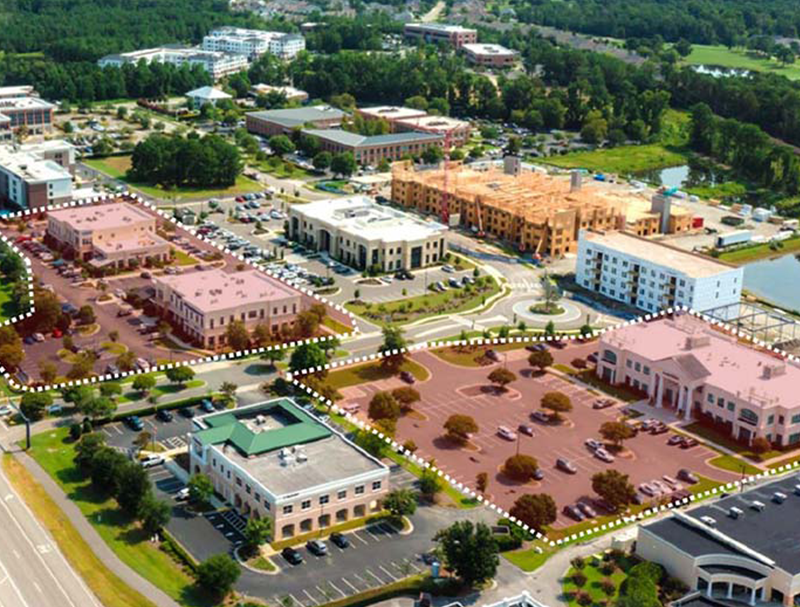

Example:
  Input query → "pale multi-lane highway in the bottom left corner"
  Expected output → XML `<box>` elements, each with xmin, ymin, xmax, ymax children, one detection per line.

<box><xmin>0</xmin><ymin>471</ymin><xmax>102</xmax><ymax>607</ymax></box>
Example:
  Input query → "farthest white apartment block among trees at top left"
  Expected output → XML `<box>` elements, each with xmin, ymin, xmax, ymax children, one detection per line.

<box><xmin>202</xmin><ymin>27</ymin><xmax>306</xmax><ymax>60</ymax></box>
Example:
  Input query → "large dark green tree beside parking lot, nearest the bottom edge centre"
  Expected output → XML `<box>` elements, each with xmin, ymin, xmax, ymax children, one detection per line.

<box><xmin>434</xmin><ymin>521</ymin><xmax>500</xmax><ymax>587</ymax></box>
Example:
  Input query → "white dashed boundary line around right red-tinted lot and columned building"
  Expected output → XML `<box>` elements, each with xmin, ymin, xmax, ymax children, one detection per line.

<box><xmin>287</xmin><ymin>306</ymin><xmax>800</xmax><ymax>548</ymax></box>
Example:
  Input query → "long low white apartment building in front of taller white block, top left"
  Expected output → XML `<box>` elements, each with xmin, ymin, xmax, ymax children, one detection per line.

<box><xmin>97</xmin><ymin>46</ymin><xmax>248</xmax><ymax>81</ymax></box>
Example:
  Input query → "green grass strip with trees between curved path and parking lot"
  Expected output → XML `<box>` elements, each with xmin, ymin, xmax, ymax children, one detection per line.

<box><xmin>25</xmin><ymin>428</ymin><xmax>213</xmax><ymax>607</ymax></box>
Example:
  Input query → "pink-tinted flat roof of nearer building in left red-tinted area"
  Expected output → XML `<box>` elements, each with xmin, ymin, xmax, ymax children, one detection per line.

<box><xmin>155</xmin><ymin>269</ymin><xmax>300</xmax><ymax>313</ymax></box>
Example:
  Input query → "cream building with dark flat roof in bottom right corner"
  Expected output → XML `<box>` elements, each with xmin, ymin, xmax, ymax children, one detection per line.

<box><xmin>636</xmin><ymin>475</ymin><xmax>800</xmax><ymax>607</ymax></box>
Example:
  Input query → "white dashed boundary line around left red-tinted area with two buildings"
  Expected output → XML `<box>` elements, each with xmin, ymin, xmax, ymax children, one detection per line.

<box><xmin>0</xmin><ymin>192</ymin><xmax>359</xmax><ymax>392</ymax></box>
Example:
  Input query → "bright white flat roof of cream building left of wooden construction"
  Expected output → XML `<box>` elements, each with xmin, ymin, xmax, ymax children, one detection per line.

<box><xmin>292</xmin><ymin>196</ymin><xmax>447</xmax><ymax>242</ymax></box>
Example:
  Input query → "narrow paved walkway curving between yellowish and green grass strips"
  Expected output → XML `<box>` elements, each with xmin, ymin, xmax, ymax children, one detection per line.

<box><xmin>14</xmin><ymin>451</ymin><xmax>178</xmax><ymax>607</ymax></box>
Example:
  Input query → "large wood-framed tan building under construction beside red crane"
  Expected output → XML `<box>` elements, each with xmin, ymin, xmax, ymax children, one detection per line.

<box><xmin>392</xmin><ymin>157</ymin><xmax>692</xmax><ymax>257</ymax></box>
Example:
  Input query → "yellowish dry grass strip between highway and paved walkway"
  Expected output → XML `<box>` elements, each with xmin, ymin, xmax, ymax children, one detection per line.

<box><xmin>3</xmin><ymin>454</ymin><xmax>155</xmax><ymax>607</ymax></box>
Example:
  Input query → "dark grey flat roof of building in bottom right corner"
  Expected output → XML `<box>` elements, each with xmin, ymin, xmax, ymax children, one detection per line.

<box><xmin>646</xmin><ymin>474</ymin><xmax>800</xmax><ymax>575</ymax></box>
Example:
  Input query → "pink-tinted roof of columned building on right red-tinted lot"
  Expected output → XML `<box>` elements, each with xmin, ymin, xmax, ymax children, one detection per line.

<box><xmin>602</xmin><ymin>314</ymin><xmax>800</xmax><ymax>407</ymax></box>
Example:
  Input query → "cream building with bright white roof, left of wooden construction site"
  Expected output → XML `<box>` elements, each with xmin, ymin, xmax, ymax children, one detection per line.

<box><xmin>289</xmin><ymin>196</ymin><xmax>447</xmax><ymax>272</ymax></box>
